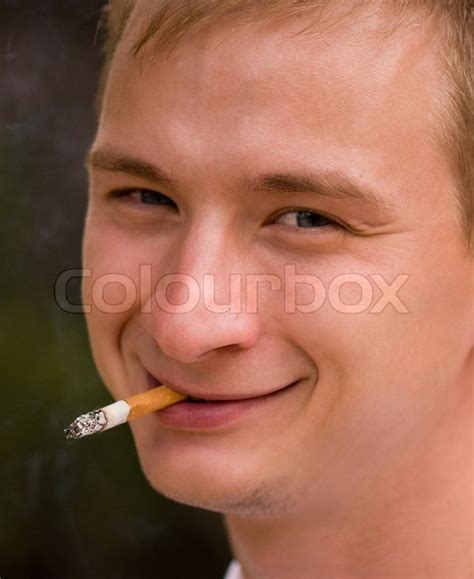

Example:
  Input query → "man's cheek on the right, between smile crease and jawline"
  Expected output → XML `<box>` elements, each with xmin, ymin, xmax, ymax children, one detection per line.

<box><xmin>286</xmin><ymin>254</ymin><xmax>469</xmax><ymax>457</ymax></box>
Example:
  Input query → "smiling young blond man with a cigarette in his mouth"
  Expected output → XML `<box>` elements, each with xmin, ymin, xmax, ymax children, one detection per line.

<box><xmin>84</xmin><ymin>0</ymin><xmax>473</xmax><ymax>579</ymax></box>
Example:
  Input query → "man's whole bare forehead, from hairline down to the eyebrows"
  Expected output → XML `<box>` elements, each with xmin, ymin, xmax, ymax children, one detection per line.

<box><xmin>98</xmin><ymin>5</ymin><xmax>456</xmax><ymax>220</ymax></box>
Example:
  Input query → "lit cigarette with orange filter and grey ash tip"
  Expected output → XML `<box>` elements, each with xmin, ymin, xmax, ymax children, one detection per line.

<box><xmin>64</xmin><ymin>386</ymin><xmax>187</xmax><ymax>440</ymax></box>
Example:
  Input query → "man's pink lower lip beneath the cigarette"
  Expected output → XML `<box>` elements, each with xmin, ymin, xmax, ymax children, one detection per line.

<box><xmin>155</xmin><ymin>382</ymin><xmax>296</xmax><ymax>430</ymax></box>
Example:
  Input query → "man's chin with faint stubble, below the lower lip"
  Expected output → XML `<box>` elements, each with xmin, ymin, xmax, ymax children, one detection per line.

<box><xmin>130</xmin><ymin>417</ymin><xmax>300</xmax><ymax>516</ymax></box>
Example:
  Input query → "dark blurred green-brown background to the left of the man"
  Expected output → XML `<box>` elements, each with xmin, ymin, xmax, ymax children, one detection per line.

<box><xmin>0</xmin><ymin>0</ymin><xmax>231</xmax><ymax>579</ymax></box>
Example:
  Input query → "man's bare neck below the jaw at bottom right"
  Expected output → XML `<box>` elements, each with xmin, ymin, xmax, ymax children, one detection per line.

<box><xmin>225</xmin><ymin>368</ymin><xmax>473</xmax><ymax>579</ymax></box>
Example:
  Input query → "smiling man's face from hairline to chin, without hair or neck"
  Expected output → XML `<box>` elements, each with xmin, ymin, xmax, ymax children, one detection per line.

<box><xmin>84</xmin><ymin>5</ymin><xmax>469</xmax><ymax>514</ymax></box>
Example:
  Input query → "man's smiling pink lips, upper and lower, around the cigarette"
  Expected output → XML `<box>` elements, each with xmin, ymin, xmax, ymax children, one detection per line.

<box><xmin>143</xmin><ymin>375</ymin><xmax>300</xmax><ymax>431</ymax></box>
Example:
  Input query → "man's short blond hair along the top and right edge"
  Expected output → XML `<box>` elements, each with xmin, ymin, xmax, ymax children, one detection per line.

<box><xmin>98</xmin><ymin>0</ymin><xmax>474</xmax><ymax>247</ymax></box>
